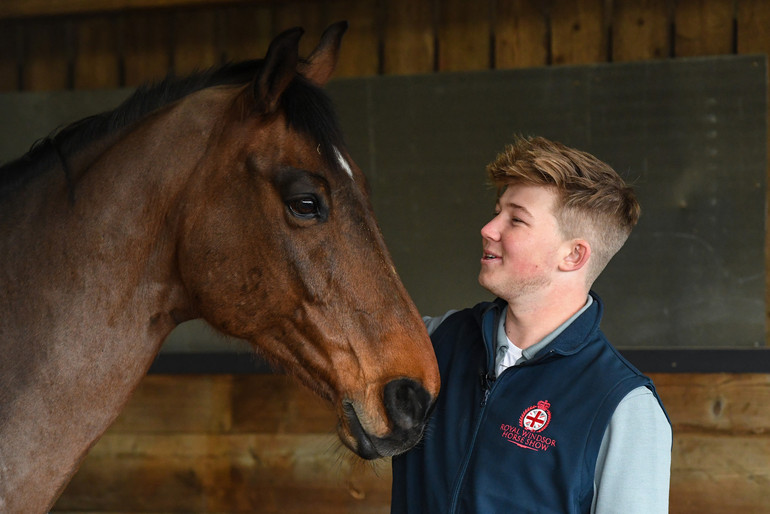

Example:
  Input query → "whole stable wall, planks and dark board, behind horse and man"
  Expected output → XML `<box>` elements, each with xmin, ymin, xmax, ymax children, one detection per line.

<box><xmin>0</xmin><ymin>0</ymin><xmax>770</xmax><ymax>513</ymax></box>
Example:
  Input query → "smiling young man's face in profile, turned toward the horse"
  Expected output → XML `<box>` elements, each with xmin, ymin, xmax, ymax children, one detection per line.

<box><xmin>479</xmin><ymin>184</ymin><xmax>565</xmax><ymax>302</ymax></box>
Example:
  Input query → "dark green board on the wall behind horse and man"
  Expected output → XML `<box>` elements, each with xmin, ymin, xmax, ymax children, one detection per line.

<box><xmin>0</xmin><ymin>56</ymin><xmax>767</xmax><ymax>351</ymax></box>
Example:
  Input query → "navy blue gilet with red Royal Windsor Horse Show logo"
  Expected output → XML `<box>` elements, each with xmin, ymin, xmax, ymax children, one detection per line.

<box><xmin>391</xmin><ymin>294</ymin><xmax>662</xmax><ymax>514</ymax></box>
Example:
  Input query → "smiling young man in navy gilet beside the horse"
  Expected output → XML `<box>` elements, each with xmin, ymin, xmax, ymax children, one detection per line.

<box><xmin>391</xmin><ymin>134</ymin><xmax>672</xmax><ymax>514</ymax></box>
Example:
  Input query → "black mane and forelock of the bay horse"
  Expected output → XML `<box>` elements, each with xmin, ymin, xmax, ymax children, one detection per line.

<box><xmin>0</xmin><ymin>60</ymin><xmax>344</xmax><ymax>193</ymax></box>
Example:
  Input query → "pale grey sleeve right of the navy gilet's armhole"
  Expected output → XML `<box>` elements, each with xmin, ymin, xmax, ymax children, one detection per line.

<box><xmin>591</xmin><ymin>387</ymin><xmax>672</xmax><ymax>514</ymax></box>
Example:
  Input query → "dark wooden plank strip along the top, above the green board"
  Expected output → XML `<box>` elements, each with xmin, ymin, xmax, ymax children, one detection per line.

<box><xmin>0</xmin><ymin>0</ymin><xmax>770</xmax><ymax>91</ymax></box>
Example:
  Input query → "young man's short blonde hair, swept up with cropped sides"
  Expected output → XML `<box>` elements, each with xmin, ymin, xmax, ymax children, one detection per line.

<box><xmin>487</xmin><ymin>137</ymin><xmax>640</xmax><ymax>286</ymax></box>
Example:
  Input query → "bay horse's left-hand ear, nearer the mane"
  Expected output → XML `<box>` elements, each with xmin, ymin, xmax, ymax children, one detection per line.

<box><xmin>254</xmin><ymin>27</ymin><xmax>304</xmax><ymax>114</ymax></box>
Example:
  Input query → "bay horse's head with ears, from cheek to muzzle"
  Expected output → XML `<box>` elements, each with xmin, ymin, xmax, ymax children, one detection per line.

<box><xmin>177</xmin><ymin>23</ymin><xmax>439</xmax><ymax>459</ymax></box>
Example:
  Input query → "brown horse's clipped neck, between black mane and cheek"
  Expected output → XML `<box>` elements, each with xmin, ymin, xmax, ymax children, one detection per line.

<box><xmin>0</xmin><ymin>87</ymin><xmax>231</xmax><ymax>512</ymax></box>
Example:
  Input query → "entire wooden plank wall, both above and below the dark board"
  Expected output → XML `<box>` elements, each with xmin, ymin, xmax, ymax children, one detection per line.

<box><xmin>0</xmin><ymin>0</ymin><xmax>770</xmax><ymax>514</ymax></box>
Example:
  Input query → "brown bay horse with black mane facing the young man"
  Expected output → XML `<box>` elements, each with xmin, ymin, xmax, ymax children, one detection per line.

<box><xmin>0</xmin><ymin>22</ymin><xmax>440</xmax><ymax>513</ymax></box>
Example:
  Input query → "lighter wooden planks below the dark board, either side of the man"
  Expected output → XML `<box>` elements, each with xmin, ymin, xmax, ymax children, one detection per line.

<box><xmin>55</xmin><ymin>374</ymin><xmax>770</xmax><ymax>514</ymax></box>
